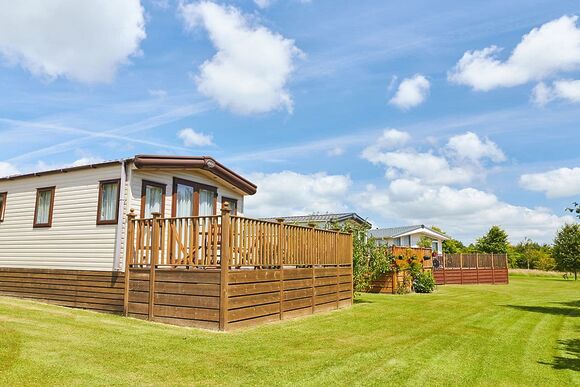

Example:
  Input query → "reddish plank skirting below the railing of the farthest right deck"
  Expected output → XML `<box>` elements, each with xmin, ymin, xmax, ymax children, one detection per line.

<box><xmin>433</xmin><ymin>268</ymin><xmax>509</xmax><ymax>285</ymax></box>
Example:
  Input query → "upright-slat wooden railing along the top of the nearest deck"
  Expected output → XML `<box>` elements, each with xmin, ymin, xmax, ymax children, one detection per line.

<box><xmin>126</xmin><ymin>209</ymin><xmax>352</xmax><ymax>268</ymax></box>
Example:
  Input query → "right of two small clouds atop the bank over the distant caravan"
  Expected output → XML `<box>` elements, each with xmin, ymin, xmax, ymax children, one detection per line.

<box><xmin>447</xmin><ymin>132</ymin><xmax>506</xmax><ymax>163</ymax></box>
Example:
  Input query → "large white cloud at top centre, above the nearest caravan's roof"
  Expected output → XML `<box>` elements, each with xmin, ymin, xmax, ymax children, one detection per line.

<box><xmin>180</xmin><ymin>1</ymin><xmax>300</xmax><ymax>114</ymax></box>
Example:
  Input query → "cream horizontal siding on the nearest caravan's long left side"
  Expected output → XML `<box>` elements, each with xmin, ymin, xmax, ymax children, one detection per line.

<box><xmin>0</xmin><ymin>164</ymin><xmax>121</xmax><ymax>271</ymax></box>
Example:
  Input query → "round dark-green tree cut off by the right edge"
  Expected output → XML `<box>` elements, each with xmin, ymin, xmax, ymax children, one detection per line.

<box><xmin>552</xmin><ymin>224</ymin><xmax>580</xmax><ymax>280</ymax></box>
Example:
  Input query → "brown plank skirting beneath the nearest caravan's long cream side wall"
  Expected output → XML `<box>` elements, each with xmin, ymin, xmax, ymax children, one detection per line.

<box><xmin>0</xmin><ymin>268</ymin><xmax>125</xmax><ymax>313</ymax></box>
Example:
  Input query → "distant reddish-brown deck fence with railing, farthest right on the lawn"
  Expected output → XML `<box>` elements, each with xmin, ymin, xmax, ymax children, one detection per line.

<box><xmin>433</xmin><ymin>253</ymin><xmax>509</xmax><ymax>285</ymax></box>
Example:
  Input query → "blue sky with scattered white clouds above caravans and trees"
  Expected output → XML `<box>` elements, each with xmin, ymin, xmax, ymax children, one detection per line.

<box><xmin>0</xmin><ymin>0</ymin><xmax>580</xmax><ymax>243</ymax></box>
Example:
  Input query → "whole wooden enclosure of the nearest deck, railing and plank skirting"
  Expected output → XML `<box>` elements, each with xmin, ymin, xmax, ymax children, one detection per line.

<box><xmin>124</xmin><ymin>207</ymin><xmax>353</xmax><ymax>330</ymax></box>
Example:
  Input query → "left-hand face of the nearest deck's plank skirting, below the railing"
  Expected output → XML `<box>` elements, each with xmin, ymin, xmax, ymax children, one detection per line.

<box><xmin>128</xmin><ymin>269</ymin><xmax>220</xmax><ymax>329</ymax></box>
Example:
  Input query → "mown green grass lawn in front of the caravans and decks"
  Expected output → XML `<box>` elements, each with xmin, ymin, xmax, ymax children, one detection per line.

<box><xmin>0</xmin><ymin>276</ymin><xmax>580</xmax><ymax>386</ymax></box>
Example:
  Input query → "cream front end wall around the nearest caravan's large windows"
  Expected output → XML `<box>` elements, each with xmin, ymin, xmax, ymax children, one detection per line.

<box><xmin>127</xmin><ymin>169</ymin><xmax>244</xmax><ymax>217</ymax></box>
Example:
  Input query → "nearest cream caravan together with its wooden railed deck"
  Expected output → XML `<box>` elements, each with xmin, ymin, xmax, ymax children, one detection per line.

<box><xmin>0</xmin><ymin>155</ymin><xmax>352</xmax><ymax>330</ymax></box>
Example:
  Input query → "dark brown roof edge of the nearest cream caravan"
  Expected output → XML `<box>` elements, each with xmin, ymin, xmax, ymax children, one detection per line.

<box><xmin>0</xmin><ymin>155</ymin><xmax>257</xmax><ymax>195</ymax></box>
